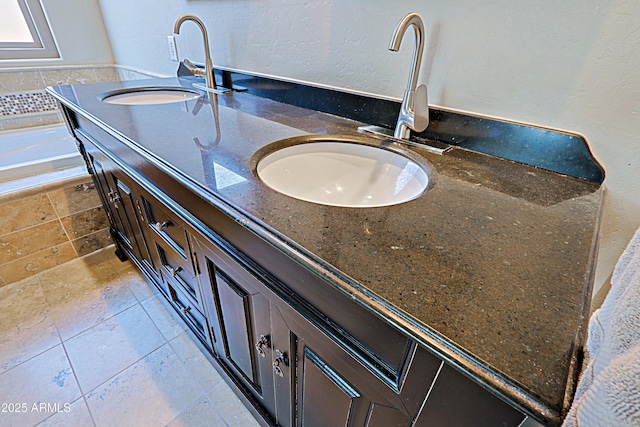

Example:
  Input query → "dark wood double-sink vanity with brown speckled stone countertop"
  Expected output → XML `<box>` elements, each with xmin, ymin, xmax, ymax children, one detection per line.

<box><xmin>48</xmin><ymin>75</ymin><xmax>604</xmax><ymax>426</ymax></box>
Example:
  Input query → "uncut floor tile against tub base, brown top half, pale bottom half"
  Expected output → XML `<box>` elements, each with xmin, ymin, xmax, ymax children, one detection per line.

<box><xmin>37</xmin><ymin>252</ymin><xmax>137</xmax><ymax>340</ymax></box>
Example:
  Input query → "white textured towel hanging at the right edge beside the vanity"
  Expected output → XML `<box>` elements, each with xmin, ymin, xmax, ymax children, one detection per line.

<box><xmin>563</xmin><ymin>229</ymin><xmax>640</xmax><ymax>427</ymax></box>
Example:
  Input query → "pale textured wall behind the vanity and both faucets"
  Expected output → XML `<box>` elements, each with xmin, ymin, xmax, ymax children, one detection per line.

<box><xmin>98</xmin><ymin>0</ymin><xmax>640</xmax><ymax>296</ymax></box>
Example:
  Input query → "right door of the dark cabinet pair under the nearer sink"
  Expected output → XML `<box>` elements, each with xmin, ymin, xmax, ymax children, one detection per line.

<box><xmin>271</xmin><ymin>304</ymin><xmax>412</xmax><ymax>427</ymax></box>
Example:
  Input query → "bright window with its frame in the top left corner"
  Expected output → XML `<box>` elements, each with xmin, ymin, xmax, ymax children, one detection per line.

<box><xmin>0</xmin><ymin>0</ymin><xmax>60</xmax><ymax>59</ymax></box>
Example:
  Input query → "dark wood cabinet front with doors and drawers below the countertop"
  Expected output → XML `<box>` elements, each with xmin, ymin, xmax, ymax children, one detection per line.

<box><xmin>72</xmin><ymin>119</ymin><xmax>525</xmax><ymax>427</ymax></box>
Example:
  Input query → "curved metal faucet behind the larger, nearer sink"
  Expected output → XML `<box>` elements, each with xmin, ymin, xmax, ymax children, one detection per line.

<box><xmin>389</xmin><ymin>13</ymin><xmax>429</xmax><ymax>139</ymax></box>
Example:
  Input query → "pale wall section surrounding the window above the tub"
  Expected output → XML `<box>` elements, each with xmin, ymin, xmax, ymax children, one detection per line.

<box><xmin>0</xmin><ymin>0</ymin><xmax>114</xmax><ymax>68</ymax></box>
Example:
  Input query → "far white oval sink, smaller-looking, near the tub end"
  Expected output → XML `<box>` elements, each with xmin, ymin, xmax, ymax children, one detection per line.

<box><xmin>100</xmin><ymin>87</ymin><xmax>201</xmax><ymax>105</ymax></box>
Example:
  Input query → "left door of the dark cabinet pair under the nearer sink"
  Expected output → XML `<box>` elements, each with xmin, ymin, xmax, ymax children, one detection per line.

<box><xmin>192</xmin><ymin>238</ymin><xmax>284</xmax><ymax>425</ymax></box>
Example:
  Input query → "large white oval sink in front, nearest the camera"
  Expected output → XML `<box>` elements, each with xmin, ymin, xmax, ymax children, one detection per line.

<box><xmin>256</xmin><ymin>136</ymin><xmax>429</xmax><ymax>208</ymax></box>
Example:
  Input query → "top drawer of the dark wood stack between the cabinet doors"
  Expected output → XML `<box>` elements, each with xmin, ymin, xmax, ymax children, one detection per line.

<box><xmin>143</xmin><ymin>197</ymin><xmax>189</xmax><ymax>259</ymax></box>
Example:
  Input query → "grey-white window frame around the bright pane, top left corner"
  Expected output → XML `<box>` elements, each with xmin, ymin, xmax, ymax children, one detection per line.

<box><xmin>0</xmin><ymin>0</ymin><xmax>60</xmax><ymax>60</ymax></box>
